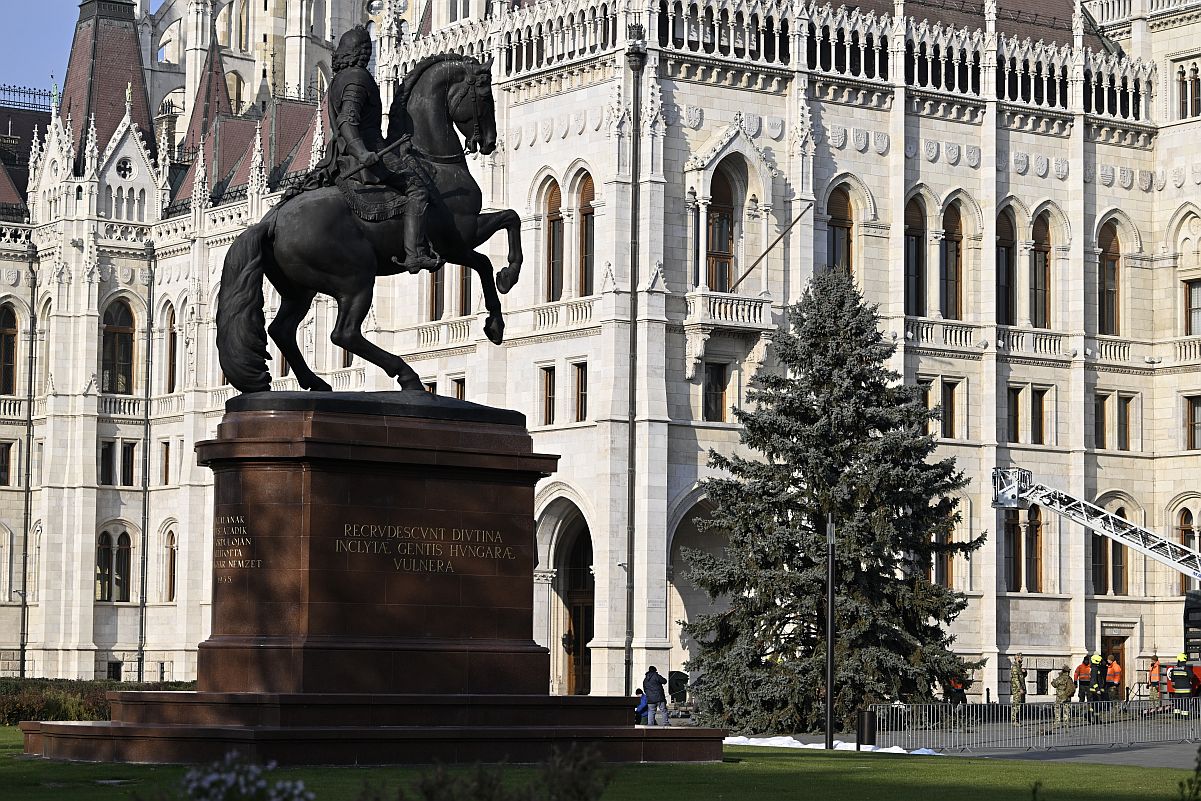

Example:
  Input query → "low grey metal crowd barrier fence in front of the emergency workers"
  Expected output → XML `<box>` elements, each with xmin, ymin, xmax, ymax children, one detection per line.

<box><xmin>870</xmin><ymin>698</ymin><xmax>1201</xmax><ymax>752</ymax></box>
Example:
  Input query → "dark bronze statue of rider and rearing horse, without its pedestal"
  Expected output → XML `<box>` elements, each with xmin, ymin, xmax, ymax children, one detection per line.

<box><xmin>216</xmin><ymin>26</ymin><xmax>522</xmax><ymax>393</ymax></box>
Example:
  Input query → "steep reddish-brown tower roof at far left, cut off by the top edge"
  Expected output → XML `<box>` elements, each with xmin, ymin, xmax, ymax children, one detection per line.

<box><xmin>61</xmin><ymin>0</ymin><xmax>156</xmax><ymax>172</ymax></box>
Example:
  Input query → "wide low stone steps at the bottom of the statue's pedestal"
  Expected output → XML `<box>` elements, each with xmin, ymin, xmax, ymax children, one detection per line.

<box><xmin>20</xmin><ymin>693</ymin><xmax>725</xmax><ymax>765</ymax></box>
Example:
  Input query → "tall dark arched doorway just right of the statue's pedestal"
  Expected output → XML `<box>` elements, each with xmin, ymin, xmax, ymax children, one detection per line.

<box><xmin>557</xmin><ymin>521</ymin><xmax>596</xmax><ymax>695</ymax></box>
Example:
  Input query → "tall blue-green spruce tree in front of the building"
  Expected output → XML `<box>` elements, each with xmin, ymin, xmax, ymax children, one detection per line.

<box><xmin>685</xmin><ymin>270</ymin><xmax>982</xmax><ymax>731</ymax></box>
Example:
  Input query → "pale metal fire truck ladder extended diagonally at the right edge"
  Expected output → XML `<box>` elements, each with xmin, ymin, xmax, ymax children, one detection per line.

<box><xmin>992</xmin><ymin>467</ymin><xmax>1201</xmax><ymax>579</ymax></box>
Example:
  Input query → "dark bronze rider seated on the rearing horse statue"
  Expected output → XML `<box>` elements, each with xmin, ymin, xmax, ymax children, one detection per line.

<box><xmin>315</xmin><ymin>25</ymin><xmax>446</xmax><ymax>274</ymax></box>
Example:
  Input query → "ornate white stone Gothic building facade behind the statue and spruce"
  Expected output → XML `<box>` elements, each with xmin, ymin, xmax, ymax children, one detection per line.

<box><xmin>0</xmin><ymin>0</ymin><xmax>1201</xmax><ymax>700</ymax></box>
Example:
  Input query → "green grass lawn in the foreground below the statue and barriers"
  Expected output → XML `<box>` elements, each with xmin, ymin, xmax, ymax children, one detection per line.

<box><xmin>0</xmin><ymin>728</ymin><xmax>1189</xmax><ymax>801</ymax></box>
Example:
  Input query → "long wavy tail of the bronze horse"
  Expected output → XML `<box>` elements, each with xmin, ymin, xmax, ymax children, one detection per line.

<box><xmin>217</xmin><ymin>210</ymin><xmax>275</xmax><ymax>393</ymax></box>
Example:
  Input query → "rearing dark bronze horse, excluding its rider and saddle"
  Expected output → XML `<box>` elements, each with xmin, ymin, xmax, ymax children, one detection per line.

<box><xmin>216</xmin><ymin>54</ymin><xmax>522</xmax><ymax>393</ymax></box>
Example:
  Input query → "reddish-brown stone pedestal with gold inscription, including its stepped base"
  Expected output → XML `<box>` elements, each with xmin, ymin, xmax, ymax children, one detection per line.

<box><xmin>22</xmin><ymin>393</ymin><xmax>724</xmax><ymax>764</ymax></box>
